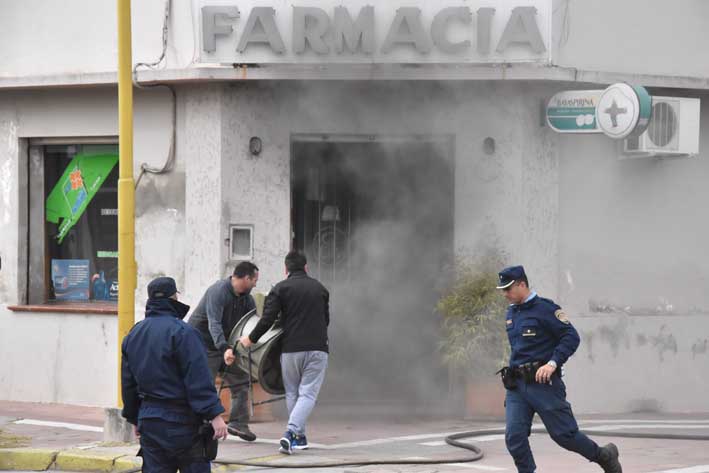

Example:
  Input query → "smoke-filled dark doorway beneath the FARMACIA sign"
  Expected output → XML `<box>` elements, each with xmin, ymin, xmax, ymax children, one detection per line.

<box><xmin>292</xmin><ymin>137</ymin><xmax>454</xmax><ymax>412</ymax></box>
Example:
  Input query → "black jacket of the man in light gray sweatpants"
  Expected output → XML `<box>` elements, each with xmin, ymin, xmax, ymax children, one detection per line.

<box><xmin>249</xmin><ymin>271</ymin><xmax>330</xmax><ymax>353</ymax></box>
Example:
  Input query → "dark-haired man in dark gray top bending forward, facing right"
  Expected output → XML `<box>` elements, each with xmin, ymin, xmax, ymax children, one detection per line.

<box><xmin>189</xmin><ymin>261</ymin><xmax>258</xmax><ymax>442</ymax></box>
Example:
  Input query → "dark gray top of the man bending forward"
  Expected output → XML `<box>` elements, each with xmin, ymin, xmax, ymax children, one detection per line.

<box><xmin>189</xmin><ymin>278</ymin><xmax>256</xmax><ymax>353</ymax></box>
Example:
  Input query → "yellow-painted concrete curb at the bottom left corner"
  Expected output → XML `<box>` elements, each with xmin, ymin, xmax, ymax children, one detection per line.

<box><xmin>0</xmin><ymin>448</ymin><xmax>143</xmax><ymax>473</ymax></box>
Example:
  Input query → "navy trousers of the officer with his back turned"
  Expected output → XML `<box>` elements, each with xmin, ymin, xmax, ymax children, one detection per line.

<box><xmin>138</xmin><ymin>418</ymin><xmax>211</xmax><ymax>473</ymax></box>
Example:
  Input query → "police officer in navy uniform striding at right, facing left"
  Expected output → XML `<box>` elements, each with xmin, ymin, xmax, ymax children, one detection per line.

<box><xmin>497</xmin><ymin>266</ymin><xmax>622</xmax><ymax>473</ymax></box>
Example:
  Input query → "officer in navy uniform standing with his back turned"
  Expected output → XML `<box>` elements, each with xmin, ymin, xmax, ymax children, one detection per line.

<box><xmin>121</xmin><ymin>277</ymin><xmax>227</xmax><ymax>473</ymax></box>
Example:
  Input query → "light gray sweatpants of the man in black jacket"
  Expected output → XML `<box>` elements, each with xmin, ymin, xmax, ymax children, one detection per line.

<box><xmin>281</xmin><ymin>351</ymin><xmax>328</xmax><ymax>435</ymax></box>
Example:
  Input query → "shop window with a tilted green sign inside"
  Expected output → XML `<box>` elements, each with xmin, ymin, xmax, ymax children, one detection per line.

<box><xmin>27</xmin><ymin>143</ymin><xmax>118</xmax><ymax>304</ymax></box>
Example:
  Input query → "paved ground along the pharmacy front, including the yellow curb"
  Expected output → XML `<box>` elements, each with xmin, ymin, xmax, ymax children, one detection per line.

<box><xmin>0</xmin><ymin>401</ymin><xmax>709</xmax><ymax>473</ymax></box>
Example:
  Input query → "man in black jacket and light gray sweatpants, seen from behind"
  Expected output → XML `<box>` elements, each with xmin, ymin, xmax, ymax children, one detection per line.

<box><xmin>240</xmin><ymin>251</ymin><xmax>330</xmax><ymax>455</ymax></box>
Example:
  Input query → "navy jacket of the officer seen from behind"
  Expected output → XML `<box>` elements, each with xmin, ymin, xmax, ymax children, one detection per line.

<box><xmin>121</xmin><ymin>299</ymin><xmax>224</xmax><ymax>424</ymax></box>
